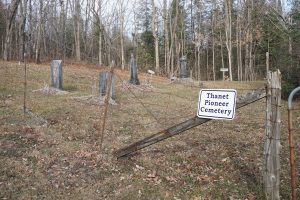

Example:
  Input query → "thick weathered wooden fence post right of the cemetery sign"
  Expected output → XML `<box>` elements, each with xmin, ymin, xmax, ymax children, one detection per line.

<box><xmin>264</xmin><ymin>70</ymin><xmax>281</xmax><ymax>200</ymax></box>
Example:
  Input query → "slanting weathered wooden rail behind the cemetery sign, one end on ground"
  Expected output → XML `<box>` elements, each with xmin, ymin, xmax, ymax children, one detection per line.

<box><xmin>114</xmin><ymin>88</ymin><xmax>266</xmax><ymax>158</ymax></box>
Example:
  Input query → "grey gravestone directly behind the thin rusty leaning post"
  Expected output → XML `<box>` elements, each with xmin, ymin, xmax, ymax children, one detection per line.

<box><xmin>99</xmin><ymin>71</ymin><xmax>116</xmax><ymax>99</ymax></box>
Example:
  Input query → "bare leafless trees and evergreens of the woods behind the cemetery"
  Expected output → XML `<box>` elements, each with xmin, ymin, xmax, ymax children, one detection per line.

<box><xmin>0</xmin><ymin>0</ymin><xmax>300</xmax><ymax>82</ymax></box>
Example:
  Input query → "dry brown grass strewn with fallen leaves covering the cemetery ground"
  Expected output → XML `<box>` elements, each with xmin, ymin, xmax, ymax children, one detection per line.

<box><xmin>0</xmin><ymin>62</ymin><xmax>300</xmax><ymax>199</ymax></box>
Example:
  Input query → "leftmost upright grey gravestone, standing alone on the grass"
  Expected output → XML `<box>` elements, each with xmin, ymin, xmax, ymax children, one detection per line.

<box><xmin>51</xmin><ymin>60</ymin><xmax>62</xmax><ymax>90</ymax></box>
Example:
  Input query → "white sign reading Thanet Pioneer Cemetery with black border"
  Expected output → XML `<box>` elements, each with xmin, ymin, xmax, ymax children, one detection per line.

<box><xmin>197</xmin><ymin>89</ymin><xmax>236</xmax><ymax>120</ymax></box>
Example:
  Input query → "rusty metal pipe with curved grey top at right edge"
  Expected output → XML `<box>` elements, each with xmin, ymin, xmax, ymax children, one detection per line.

<box><xmin>288</xmin><ymin>86</ymin><xmax>300</xmax><ymax>200</ymax></box>
